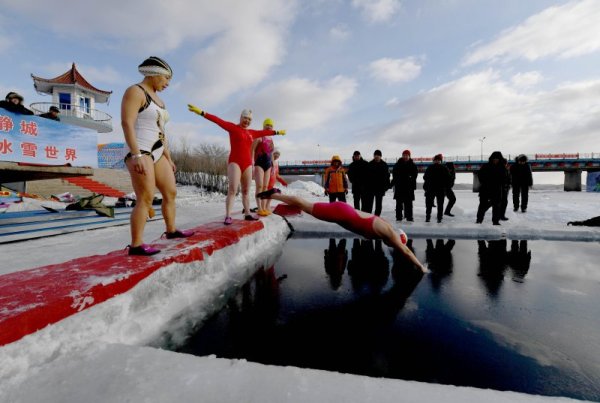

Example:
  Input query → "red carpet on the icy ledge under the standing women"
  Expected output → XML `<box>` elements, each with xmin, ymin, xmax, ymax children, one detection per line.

<box><xmin>0</xmin><ymin>220</ymin><xmax>264</xmax><ymax>346</ymax></box>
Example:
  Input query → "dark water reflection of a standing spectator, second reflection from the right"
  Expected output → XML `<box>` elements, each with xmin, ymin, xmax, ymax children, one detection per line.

<box><xmin>477</xmin><ymin>239</ymin><xmax>508</xmax><ymax>298</ymax></box>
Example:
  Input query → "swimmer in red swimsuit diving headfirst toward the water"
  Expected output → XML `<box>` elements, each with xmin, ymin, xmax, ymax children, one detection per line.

<box><xmin>258</xmin><ymin>188</ymin><xmax>429</xmax><ymax>273</ymax></box>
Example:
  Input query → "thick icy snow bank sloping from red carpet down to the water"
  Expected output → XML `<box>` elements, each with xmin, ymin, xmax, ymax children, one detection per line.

<box><xmin>0</xmin><ymin>217</ymin><xmax>289</xmax><ymax>395</ymax></box>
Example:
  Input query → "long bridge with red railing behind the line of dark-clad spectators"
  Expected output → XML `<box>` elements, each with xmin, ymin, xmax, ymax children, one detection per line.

<box><xmin>279</xmin><ymin>153</ymin><xmax>600</xmax><ymax>191</ymax></box>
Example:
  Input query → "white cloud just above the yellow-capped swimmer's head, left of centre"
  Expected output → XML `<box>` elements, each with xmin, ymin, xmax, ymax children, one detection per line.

<box><xmin>241</xmin><ymin>76</ymin><xmax>357</xmax><ymax>130</ymax></box>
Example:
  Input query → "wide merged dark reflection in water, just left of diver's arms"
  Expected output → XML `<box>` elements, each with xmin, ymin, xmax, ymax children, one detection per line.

<box><xmin>348</xmin><ymin>239</ymin><xmax>390</xmax><ymax>294</ymax></box>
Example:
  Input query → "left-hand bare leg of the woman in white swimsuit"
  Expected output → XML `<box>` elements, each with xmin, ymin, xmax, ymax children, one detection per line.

<box><xmin>127</xmin><ymin>155</ymin><xmax>155</xmax><ymax>247</ymax></box>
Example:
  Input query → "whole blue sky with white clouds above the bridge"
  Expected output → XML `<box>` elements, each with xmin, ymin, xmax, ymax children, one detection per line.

<box><xmin>0</xmin><ymin>0</ymin><xmax>600</xmax><ymax>164</ymax></box>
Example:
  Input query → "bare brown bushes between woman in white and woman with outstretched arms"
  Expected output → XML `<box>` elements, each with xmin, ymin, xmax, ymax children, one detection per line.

<box><xmin>171</xmin><ymin>139</ymin><xmax>229</xmax><ymax>194</ymax></box>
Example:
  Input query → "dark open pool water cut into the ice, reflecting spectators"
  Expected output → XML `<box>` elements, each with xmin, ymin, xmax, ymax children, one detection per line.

<box><xmin>178</xmin><ymin>238</ymin><xmax>600</xmax><ymax>401</ymax></box>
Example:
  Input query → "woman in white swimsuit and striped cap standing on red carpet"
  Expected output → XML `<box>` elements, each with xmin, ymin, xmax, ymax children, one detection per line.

<box><xmin>121</xmin><ymin>56</ymin><xmax>193</xmax><ymax>255</ymax></box>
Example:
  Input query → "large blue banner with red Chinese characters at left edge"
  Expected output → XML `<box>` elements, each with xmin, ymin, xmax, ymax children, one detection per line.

<box><xmin>0</xmin><ymin>109</ymin><xmax>98</xmax><ymax>167</ymax></box>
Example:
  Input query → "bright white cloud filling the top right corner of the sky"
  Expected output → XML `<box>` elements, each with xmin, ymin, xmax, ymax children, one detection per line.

<box><xmin>463</xmin><ymin>0</ymin><xmax>600</xmax><ymax>65</ymax></box>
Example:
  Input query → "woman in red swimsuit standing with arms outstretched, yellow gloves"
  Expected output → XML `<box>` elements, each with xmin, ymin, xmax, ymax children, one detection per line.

<box><xmin>188</xmin><ymin>104</ymin><xmax>285</xmax><ymax>225</ymax></box>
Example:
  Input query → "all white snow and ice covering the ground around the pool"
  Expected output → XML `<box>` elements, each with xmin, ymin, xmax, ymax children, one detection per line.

<box><xmin>0</xmin><ymin>181</ymin><xmax>600</xmax><ymax>402</ymax></box>
